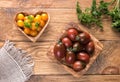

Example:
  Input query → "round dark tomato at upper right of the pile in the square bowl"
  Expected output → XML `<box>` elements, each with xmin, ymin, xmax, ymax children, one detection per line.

<box><xmin>78</xmin><ymin>32</ymin><xmax>90</xmax><ymax>44</ymax></box>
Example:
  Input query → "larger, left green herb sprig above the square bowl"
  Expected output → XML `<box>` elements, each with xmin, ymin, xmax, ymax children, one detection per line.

<box><xmin>76</xmin><ymin>0</ymin><xmax>109</xmax><ymax>30</ymax></box>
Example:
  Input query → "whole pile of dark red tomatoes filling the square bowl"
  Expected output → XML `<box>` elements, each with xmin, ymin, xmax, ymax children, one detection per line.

<box><xmin>54</xmin><ymin>28</ymin><xmax>95</xmax><ymax>72</ymax></box>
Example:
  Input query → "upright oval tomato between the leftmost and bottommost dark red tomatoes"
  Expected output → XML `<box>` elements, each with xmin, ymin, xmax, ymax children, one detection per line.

<box><xmin>65</xmin><ymin>51</ymin><xmax>75</xmax><ymax>64</ymax></box>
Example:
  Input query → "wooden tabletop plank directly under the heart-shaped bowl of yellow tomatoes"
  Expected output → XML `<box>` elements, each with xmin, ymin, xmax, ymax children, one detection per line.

<box><xmin>0</xmin><ymin>8</ymin><xmax>120</xmax><ymax>41</ymax></box>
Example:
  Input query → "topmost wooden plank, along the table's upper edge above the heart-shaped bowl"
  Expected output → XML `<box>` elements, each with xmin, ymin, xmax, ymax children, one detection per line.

<box><xmin>0</xmin><ymin>0</ymin><xmax>110</xmax><ymax>8</ymax></box>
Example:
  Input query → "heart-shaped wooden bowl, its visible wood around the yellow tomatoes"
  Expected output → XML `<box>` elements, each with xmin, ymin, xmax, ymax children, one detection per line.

<box><xmin>15</xmin><ymin>11</ymin><xmax>50</xmax><ymax>42</ymax></box>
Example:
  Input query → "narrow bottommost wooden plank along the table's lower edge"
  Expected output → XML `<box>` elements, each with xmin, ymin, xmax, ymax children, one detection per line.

<box><xmin>27</xmin><ymin>75</ymin><xmax>120</xmax><ymax>82</ymax></box>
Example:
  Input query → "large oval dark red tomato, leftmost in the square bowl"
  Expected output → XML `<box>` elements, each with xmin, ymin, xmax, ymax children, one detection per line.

<box><xmin>54</xmin><ymin>43</ymin><xmax>66</xmax><ymax>60</ymax></box>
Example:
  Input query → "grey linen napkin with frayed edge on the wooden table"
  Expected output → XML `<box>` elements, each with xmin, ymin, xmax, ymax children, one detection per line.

<box><xmin>0</xmin><ymin>40</ymin><xmax>34</xmax><ymax>82</ymax></box>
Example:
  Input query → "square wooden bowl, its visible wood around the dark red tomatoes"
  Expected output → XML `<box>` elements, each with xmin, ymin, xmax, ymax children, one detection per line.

<box><xmin>47</xmin><ymin>23</ymin><xmax>103</xmax><ymax>77</ymax></box>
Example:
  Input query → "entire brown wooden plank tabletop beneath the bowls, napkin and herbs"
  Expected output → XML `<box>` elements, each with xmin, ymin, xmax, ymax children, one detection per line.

<box><xmin>0</xmin><ymin>0</ymin><xmax>120</xmax><ymax>82</ymax></box>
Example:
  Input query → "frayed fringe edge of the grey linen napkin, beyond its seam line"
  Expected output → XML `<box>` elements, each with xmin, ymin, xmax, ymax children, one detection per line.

<box><xmin>3</xmin><ymin>40</ymin><xmax>34</xmax><ymax>81</ymax></box>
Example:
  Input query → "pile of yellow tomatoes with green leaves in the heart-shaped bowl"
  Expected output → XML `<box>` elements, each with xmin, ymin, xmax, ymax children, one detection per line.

<box><xmin>16</xmin><ymin>12</ymin><xmax>48</xmax><ymax>37</ymax></box>
